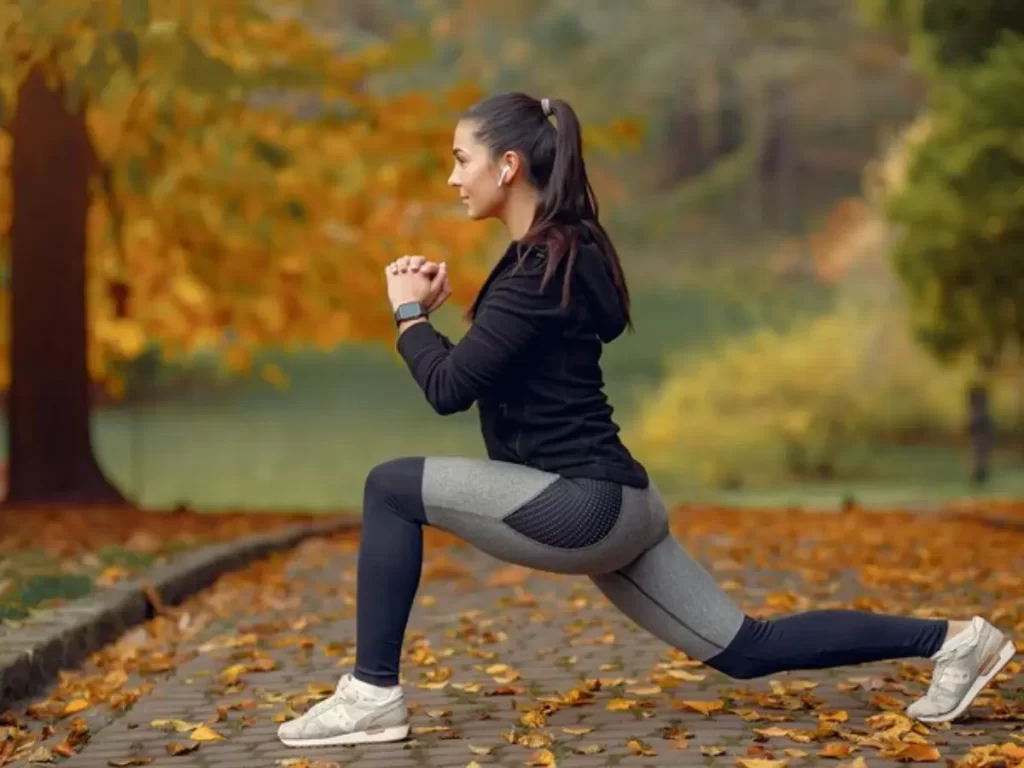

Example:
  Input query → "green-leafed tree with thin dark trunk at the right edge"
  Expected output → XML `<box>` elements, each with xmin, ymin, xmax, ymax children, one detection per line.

<box><xmin>862</xmin><ymin>0</ymin><xmax>1024</xmax><ymax>481</ymax></box>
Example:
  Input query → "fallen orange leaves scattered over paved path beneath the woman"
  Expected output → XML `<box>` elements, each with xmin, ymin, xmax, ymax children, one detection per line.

<box><xmin>0</xmin><ymin>507</ymin><xmax>1024</xmax><ymax>768</ymax></box>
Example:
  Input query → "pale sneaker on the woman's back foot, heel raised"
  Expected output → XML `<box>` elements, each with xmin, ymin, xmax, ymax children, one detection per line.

<box><xmin>906</xmin><ymin>616</ymin><xmax>1016</xmax><ymax>723</ymax></box>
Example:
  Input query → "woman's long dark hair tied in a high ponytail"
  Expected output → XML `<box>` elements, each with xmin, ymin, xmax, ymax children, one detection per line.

<box><xmin>463</xmin><ymin>92</ymin><xmax>633</xmax><ymax>329</ymax></box>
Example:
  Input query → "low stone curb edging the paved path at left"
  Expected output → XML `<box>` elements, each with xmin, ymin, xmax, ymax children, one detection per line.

<box><xmin>0</xmin><ymin>517</ymin><xmax>359</xmax><ymax>712</ymax></box>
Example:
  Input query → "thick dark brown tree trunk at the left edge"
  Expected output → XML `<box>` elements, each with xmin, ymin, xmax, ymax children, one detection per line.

<box><xmin>6</xmin><ymin>67</ymin><xmax>125</xmax><ymax>506</ymax></box>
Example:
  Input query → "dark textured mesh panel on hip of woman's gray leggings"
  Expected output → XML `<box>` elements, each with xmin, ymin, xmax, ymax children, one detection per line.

<box><xmin>504</xmin><ymin>477</ymin><xmax>623</xmax><ymax>549</ymax></box>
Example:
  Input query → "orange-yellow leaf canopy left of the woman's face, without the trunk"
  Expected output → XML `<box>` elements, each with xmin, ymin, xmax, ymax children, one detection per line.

<box><xmin>0</xmin><ymin>0</ymin><xmax>487</xmax><ymax>393</ymax></box>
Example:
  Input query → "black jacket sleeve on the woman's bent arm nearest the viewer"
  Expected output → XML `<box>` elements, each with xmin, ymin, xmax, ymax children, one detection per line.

<box><xmin>397</xmin><ymin>272</ymin><xmax>564</xmax><ymax>415</ymax></box>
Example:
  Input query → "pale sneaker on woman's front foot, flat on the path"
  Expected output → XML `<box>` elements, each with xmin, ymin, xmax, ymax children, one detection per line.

<box><xmin>278</xmin><ymin>675</ymin><xmax>409</xmax><ymax>746</ymax></box>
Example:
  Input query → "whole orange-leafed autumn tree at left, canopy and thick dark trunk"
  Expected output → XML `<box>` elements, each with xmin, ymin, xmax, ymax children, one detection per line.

<box><xmin>0</xmin><ymin>0</ymin><xmax>487</xmax><ymax>512</ymax></box>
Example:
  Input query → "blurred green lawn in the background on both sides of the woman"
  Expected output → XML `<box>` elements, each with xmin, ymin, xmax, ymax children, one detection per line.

<box><xmin>4</xmin><ymin>280</ymin><xmax>1024</xmax><ymax>512</ymax></box>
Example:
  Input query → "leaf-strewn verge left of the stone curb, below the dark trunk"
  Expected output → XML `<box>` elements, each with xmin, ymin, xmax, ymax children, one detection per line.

<box><xmin>0</xmin><ymin>507</ymin><xmax>348</xmax><ymax>627</ymax></box>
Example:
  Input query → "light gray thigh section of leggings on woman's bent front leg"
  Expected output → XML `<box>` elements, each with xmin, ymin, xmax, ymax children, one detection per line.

<box><xmin>423</xmin><ymin>457</ymin><xmax>651</xmax><ymax>573</ymax></box>
